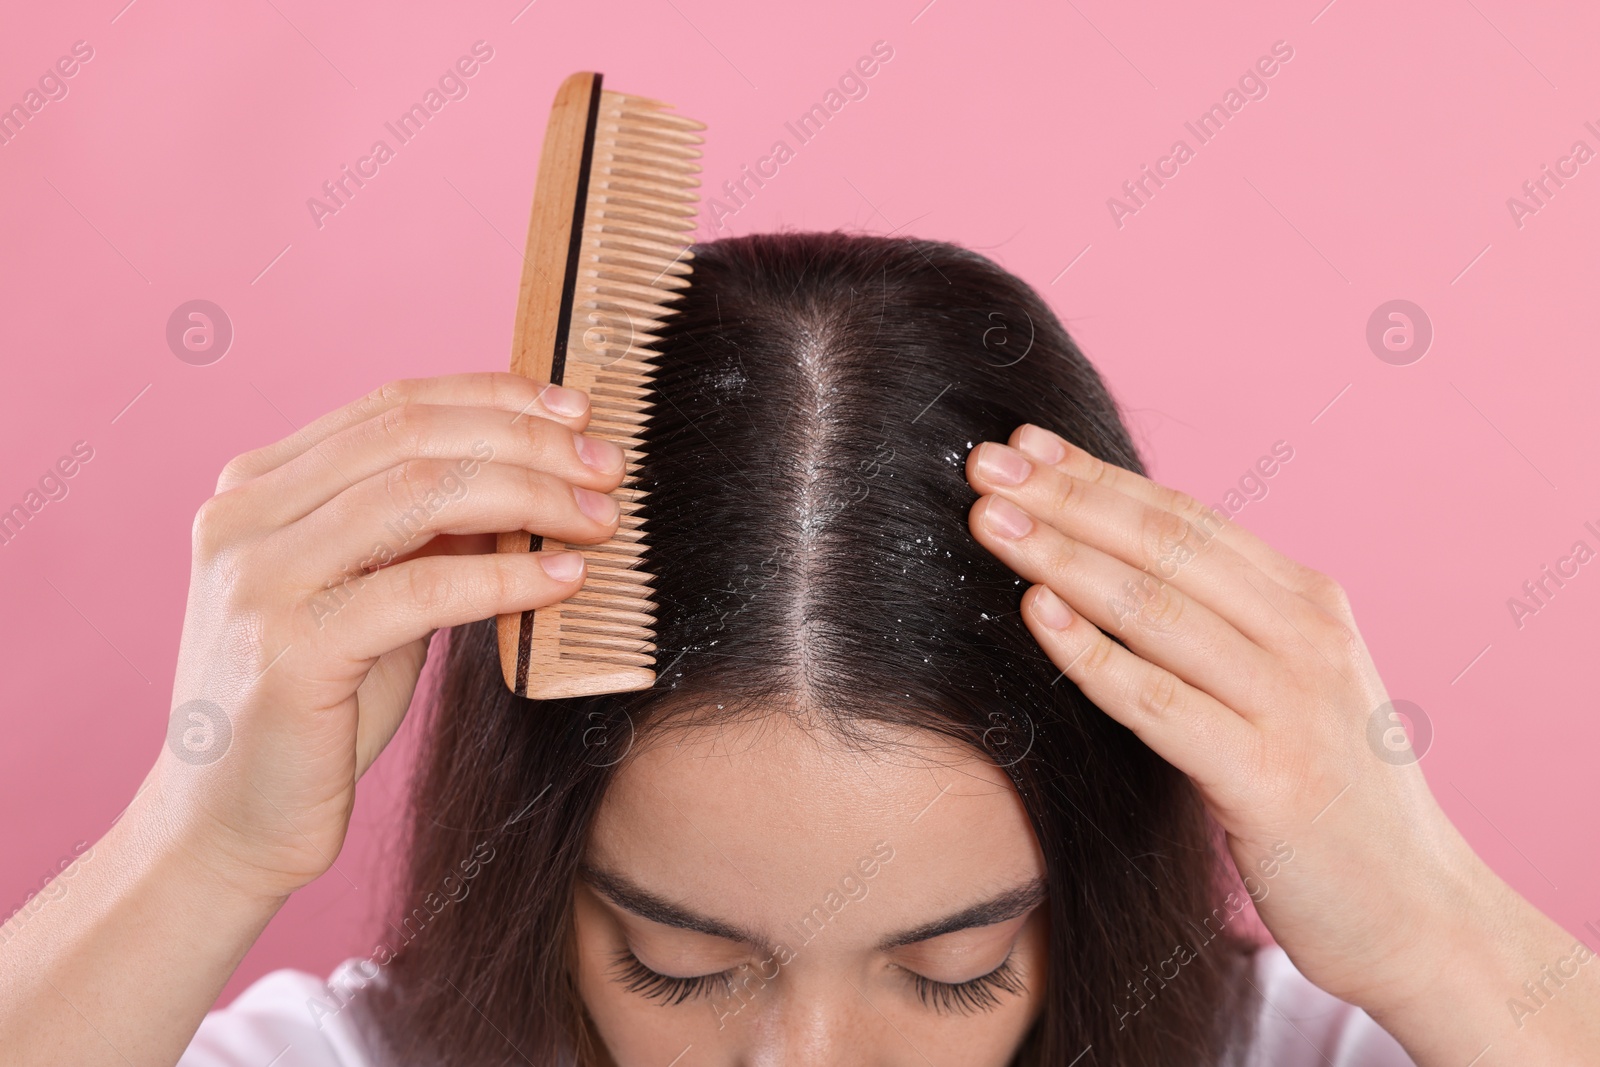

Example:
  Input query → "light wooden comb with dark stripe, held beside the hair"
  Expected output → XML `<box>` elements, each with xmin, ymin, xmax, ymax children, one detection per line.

<box><xmin>498</xmin><ymin>72</ymin><xmax>706</xmax><ymax>701</ymax></box>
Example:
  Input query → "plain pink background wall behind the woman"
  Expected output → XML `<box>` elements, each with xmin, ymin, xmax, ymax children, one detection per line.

<box><xmin>0</xmin><ymin>0</ymin><xmax>1600</xmax><ymax>997</ymax></box>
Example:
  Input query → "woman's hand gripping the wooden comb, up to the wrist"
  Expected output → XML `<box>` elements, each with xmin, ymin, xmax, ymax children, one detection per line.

<box><xmin>147</xmin><ymin>373</ymin><xmax>624</xmax><ymax>897</ymax></box>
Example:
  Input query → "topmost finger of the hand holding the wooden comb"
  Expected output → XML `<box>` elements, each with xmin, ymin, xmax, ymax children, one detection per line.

<box><xmin>216</xmin><ymin>371</ymin><xmax>589</xmax><ymax>493</ymax></box>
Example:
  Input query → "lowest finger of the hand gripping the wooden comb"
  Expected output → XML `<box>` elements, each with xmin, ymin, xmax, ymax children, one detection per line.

<box><xmin>318</xmin><ymin>550</ymin><xmax>587</xmax><ymax>664</ymax></box>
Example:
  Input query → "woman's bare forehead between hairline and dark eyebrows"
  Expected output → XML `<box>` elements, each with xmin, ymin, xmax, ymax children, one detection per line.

<box><xmin>587</xmin><ymin>713</ymin><xmax>1043</xmax><ymax>937</ymax></box>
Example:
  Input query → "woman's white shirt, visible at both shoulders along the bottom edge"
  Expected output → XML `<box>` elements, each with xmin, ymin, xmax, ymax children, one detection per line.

<box><xmin>178</xmin><ymin>945</ymin><xmax>1414</xmax><ymax>1067</ymax></box>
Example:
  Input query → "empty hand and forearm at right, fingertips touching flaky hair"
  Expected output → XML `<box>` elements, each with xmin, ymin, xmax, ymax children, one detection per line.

<box><xmin>966</xmin><ymin>426</ymin><xmax>1600</xmax><ymax>1067</ymax></box>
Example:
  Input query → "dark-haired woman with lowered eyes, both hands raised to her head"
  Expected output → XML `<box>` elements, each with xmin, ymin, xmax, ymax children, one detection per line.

<box><xmin>0</xmin><ymin>234</ymin><xmax>1600</xmax><ymax>1067</ymax></box>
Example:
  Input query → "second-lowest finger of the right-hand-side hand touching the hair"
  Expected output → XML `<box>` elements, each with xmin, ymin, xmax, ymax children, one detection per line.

<box><xmin>970</xmin><ymin>494</ymin><xmax>1278</xmax><ymax>715</ymax></box>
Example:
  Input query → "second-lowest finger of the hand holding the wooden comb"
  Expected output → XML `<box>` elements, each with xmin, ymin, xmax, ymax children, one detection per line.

<box><xmin>281</xmin><ymin>459</ymin><xmax>621</xmax><ymax>587</ymax></box>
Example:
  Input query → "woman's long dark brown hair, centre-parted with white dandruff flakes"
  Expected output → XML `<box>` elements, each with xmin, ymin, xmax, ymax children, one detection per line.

<box><xmin>370</xmin><ymin>232</ymin><xmax>1256</xmax><ymax>1067</ymax></box>
